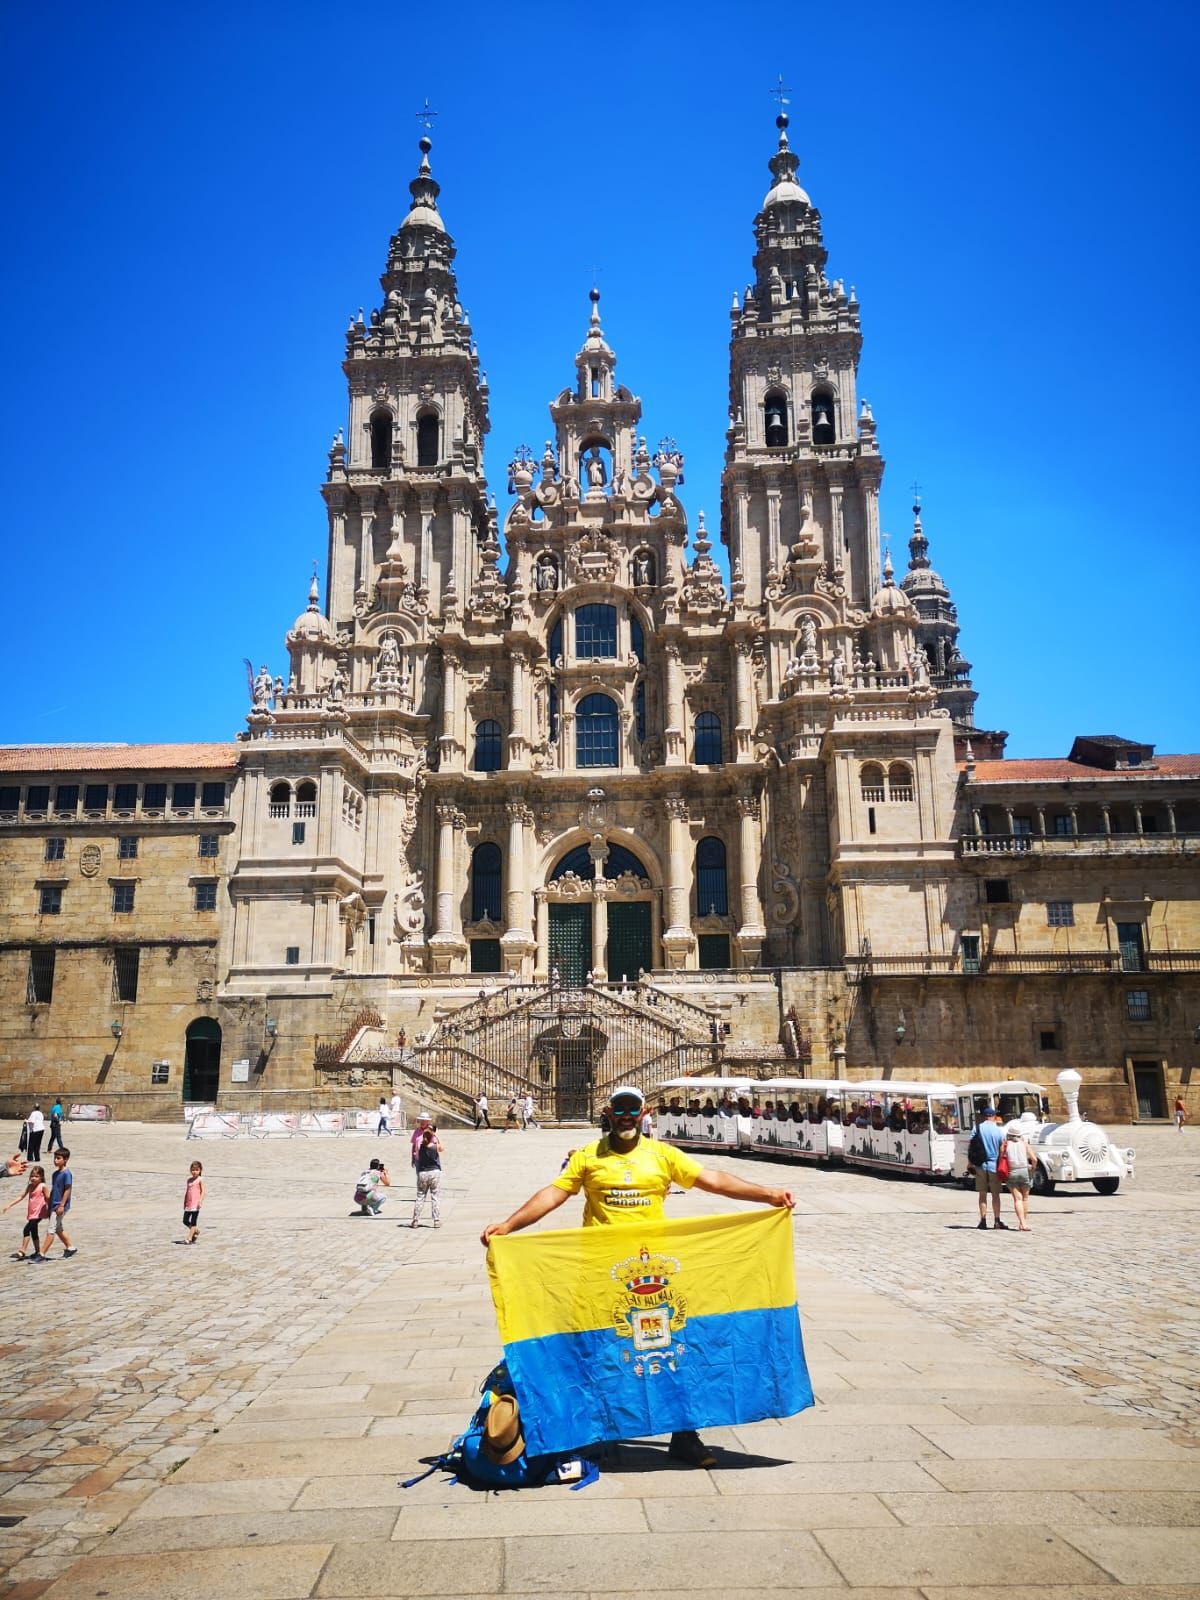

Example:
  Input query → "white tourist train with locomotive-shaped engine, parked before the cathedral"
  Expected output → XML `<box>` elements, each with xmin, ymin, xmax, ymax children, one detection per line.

<box><xmin>654</xmin><ymin>1070</ymin><xmax>1134</xmax><ymax>1194</ymax></box>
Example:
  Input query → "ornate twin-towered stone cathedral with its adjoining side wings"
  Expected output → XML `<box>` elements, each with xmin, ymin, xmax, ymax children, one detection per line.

<box><xmin>0</xmin><ymin>115</ymin><xmax>1200</xmax><ymax>1117</ymax></box>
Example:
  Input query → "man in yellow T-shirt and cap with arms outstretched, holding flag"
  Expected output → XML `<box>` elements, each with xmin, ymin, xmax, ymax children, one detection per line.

<box><xmin>480</xmin><ymin>1085</ymin><xmax>795</xmax><ymax>1467</ymax></box>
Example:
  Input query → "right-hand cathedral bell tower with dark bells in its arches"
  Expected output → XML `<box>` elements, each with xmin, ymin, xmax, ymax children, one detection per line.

<box><xmin>722</xmin><ymin>112</ymin><xmax>883</xmax><ymax>605</ymax></box>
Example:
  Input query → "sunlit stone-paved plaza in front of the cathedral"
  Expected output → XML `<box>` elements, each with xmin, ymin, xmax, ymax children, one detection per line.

<box><xmin>0</xmin><ymin>1125</ymin><xmax>1200</xmax><ymax>1600</ymax></box>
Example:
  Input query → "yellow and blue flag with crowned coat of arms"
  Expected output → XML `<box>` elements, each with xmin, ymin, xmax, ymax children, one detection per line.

<box><xmin>488</xmin><ymin>1208</ymin><xmax>813</xmax><ymax>1454</ymax></box>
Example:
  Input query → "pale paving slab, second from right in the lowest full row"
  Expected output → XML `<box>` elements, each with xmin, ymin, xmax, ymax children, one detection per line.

<box><xmin>816</xmin><ymin>1526</ymin><xmax>1106</xmax><ymax>1594</ymax></box>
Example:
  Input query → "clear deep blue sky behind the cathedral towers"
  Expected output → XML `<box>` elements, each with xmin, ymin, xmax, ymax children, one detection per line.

<box><xmin>0</xmin><ymin>0</ymin><xmax>1200</xmax><ymax>755</ymax></box>
